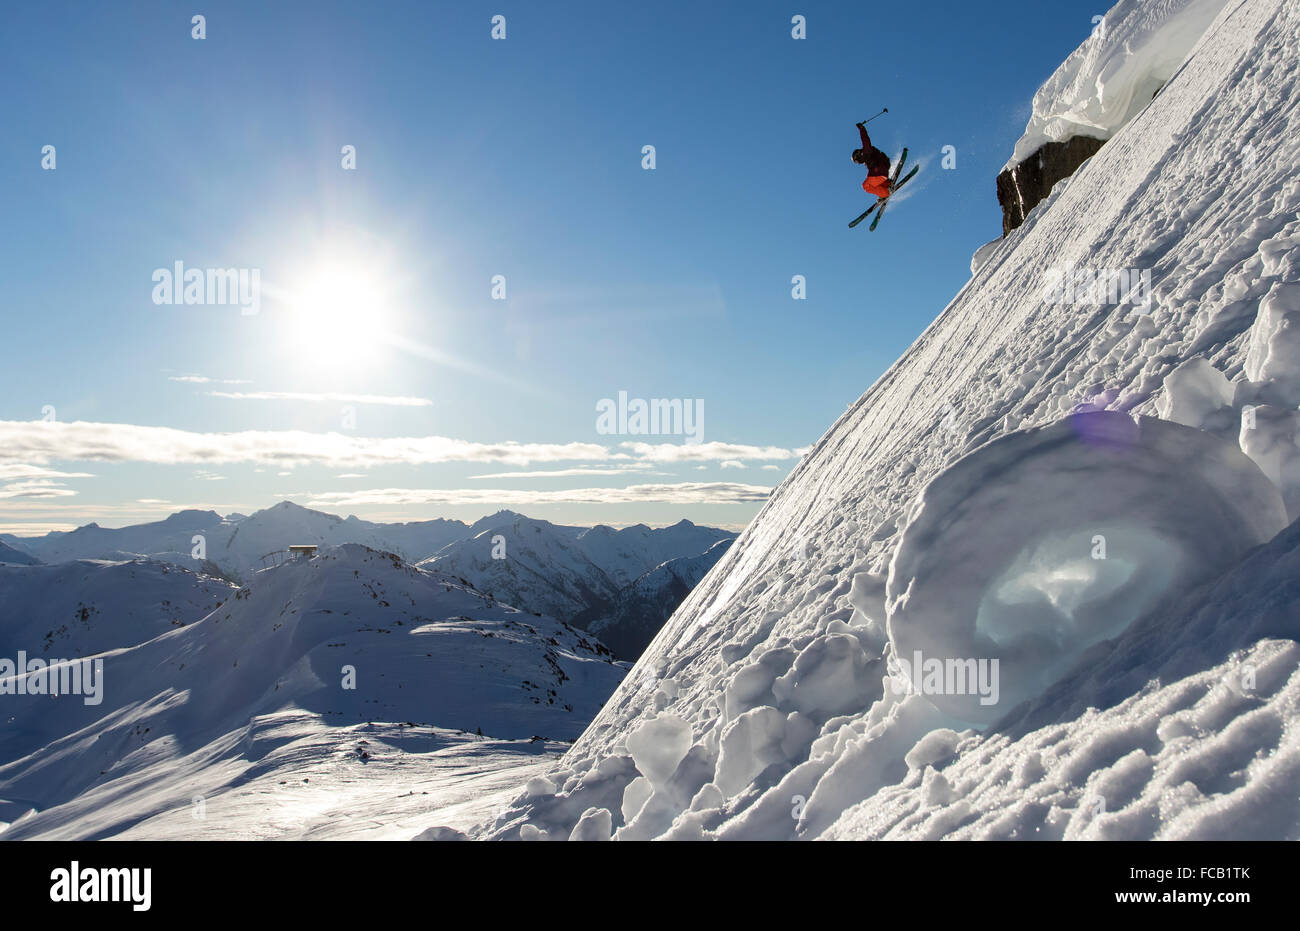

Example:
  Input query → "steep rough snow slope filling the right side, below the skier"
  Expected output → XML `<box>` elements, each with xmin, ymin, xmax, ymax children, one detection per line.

<box><xmin>481</xmin><ymin>0</ymin><xmax>1300</xmax><ymax>839</ymax></box>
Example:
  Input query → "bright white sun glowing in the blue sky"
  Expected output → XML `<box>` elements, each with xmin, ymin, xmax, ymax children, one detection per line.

<box><xmin>287</xmin><ymin>263</ymin><xmax>390</xmax><ymax>368</ymax></box>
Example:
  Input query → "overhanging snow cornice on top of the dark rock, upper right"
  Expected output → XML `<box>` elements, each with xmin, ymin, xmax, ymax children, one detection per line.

<box><xmin>1004</xmin><ymin>0</ymin><xmax>1229</xmax><ymax>170</ymax></box>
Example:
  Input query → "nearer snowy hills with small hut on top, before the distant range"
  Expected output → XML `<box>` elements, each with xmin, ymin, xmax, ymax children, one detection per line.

<box><xmin>0</xmin><ymin>544</ymin><xmax>627</xmax><ymax>839</ymax></box>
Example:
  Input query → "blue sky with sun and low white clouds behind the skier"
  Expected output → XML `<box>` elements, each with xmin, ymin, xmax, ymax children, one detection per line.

<box><xmin>0</xmin><ymin>0</ymin><xmax>1105</xmax><ymax>532</ymax></box>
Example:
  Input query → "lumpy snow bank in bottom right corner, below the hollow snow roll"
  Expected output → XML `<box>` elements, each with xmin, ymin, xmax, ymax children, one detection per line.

<box><xmin>826</xmin><ymin>525</ymin><xmax>1300</xmax><ymax>840</ymax></box>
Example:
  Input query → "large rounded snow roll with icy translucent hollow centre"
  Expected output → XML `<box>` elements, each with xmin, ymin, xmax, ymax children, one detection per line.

<box><xmin>887</xmin><ymin>411</ymin><xmax>1287</xmax><ymax>724</ymax></box>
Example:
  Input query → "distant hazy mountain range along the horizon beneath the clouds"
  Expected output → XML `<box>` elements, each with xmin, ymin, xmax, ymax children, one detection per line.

<box><xmin>0</xmin><ymin>501</ymin><xmax>736</xmax><ymax>659</ymax></box>
